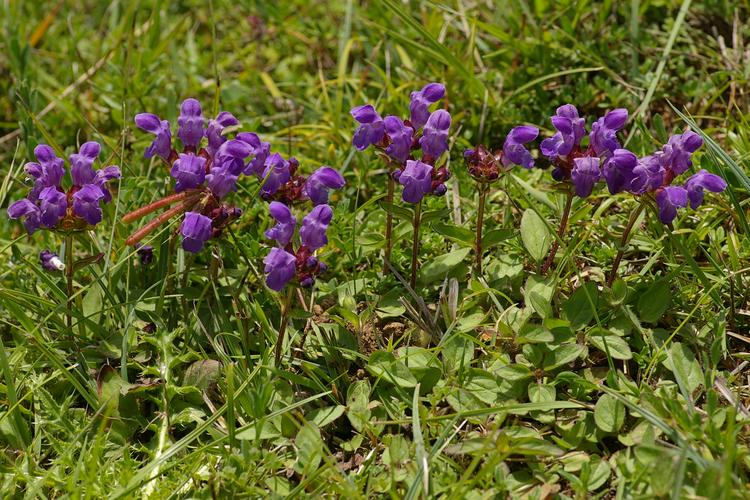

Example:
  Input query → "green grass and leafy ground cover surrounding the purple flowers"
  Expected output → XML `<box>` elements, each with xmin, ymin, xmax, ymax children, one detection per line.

<box><xmin>0</xmin><ymin>0</ymin><xmax>750</xmax><ymax>498</ymax></box>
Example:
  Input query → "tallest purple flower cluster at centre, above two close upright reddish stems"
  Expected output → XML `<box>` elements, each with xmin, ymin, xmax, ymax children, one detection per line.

<box><xmin>351</xmin><ymin>83</ymin><xmax>451</xmax><ymax>203</ymax></box>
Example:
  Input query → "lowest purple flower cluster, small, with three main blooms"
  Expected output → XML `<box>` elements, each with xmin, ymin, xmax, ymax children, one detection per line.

<box><xmin>263</xmin><ymin>201</ymin><xmax>333</xmax><ymax>291</ymax></box>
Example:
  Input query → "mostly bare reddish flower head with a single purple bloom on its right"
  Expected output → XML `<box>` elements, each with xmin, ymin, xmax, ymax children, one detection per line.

<box><xmin>464</xmin><ymin>125</ymin><xmax>539</xmax><ymax>183</ymax></box>
